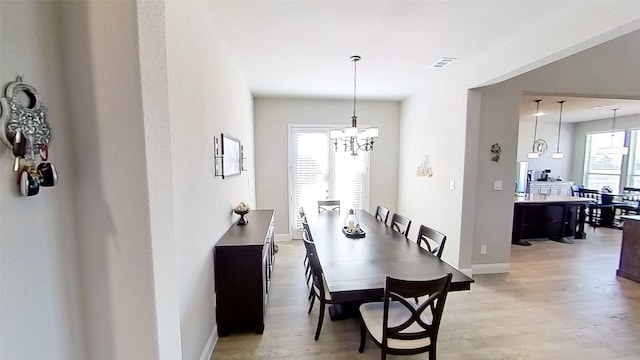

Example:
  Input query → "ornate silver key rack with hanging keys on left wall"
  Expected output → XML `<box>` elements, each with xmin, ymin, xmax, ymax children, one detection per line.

<box><xmin>0</xmin><ymin>76</ymin><xmax>58</xmax><ymax>196</ymax></box>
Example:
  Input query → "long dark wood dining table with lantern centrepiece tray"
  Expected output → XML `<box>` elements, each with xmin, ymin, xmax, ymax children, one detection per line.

<box><xmin>307</xmin><ymin>210</ymin><xmax>473</xmax><ymax>316</ymax></box>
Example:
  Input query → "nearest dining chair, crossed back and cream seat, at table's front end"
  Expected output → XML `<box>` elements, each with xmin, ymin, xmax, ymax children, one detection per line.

<box><xmin>358</xmin><ymin>273</ymin><xmax>452</xmax><ymax>360</ymax></box>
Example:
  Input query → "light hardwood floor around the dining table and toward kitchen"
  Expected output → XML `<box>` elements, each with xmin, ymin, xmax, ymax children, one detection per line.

<box><xmin>212</xmin><ymin>229</ymin><xmax>640</xmax><ymax>360</ymax></box>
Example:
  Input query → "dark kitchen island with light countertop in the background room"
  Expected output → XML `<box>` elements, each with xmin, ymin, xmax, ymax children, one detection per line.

<box><xmin>511</xmin><ymin>194</ymin><xmax>592</xmax><ymax>246</ymax></box>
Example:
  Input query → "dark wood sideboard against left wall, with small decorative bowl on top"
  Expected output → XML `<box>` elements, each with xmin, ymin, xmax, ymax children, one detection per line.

<box><xmin>213</xmin><ymin>210</ymin><xmax>275</xmax><ymax>336</ymax></box>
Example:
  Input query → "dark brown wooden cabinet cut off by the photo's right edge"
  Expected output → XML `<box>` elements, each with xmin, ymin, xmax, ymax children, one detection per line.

<box><xmin>616</xmin><ymin>215</ymin><xmax>640</xmax><ymax>282</ymax></box>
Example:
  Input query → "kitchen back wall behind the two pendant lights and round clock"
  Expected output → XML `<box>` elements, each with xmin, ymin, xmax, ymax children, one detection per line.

<box><xmin>514</xmin><ymin>116</ymin><xmax>580</xmax><ymax>181</ymax></box>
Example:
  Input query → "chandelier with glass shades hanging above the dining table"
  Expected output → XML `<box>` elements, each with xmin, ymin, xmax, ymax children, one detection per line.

<box><xmin>329</xmin><ymin>55</ymin><xmax>378</xmax><ymax>156</ymax></box>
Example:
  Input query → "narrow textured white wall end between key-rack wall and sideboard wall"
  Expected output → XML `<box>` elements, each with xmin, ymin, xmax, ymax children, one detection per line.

<box><xmin>137</xmin><ymin>1</ymin><xmax>182</xmax><ymax>360</ymax></box>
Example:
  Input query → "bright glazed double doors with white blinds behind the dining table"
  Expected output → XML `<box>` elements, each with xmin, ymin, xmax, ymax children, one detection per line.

<box><xmin>289</xmin><ymin>126</ymin><xmax>369</xmax><ymax>238</ymax></box>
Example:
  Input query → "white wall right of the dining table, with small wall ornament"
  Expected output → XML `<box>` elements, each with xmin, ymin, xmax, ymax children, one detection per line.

<box><xmin>398</xmin><ymin>83</ymin><xmax>468</xmax><ymax>267</ymax></box>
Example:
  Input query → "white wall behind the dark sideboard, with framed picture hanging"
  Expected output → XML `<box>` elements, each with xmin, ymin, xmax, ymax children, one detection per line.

<box><xmin>166</xmin><ymin>2</ymin><xmax>256</xmax><ymax>359</ymax></box>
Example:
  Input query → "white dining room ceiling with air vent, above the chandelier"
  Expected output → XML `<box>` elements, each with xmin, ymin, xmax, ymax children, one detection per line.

<box><xmin>207</xmin><ymin>0</ymin><xmax>577</xmax><ymax>100</ymax></box>
